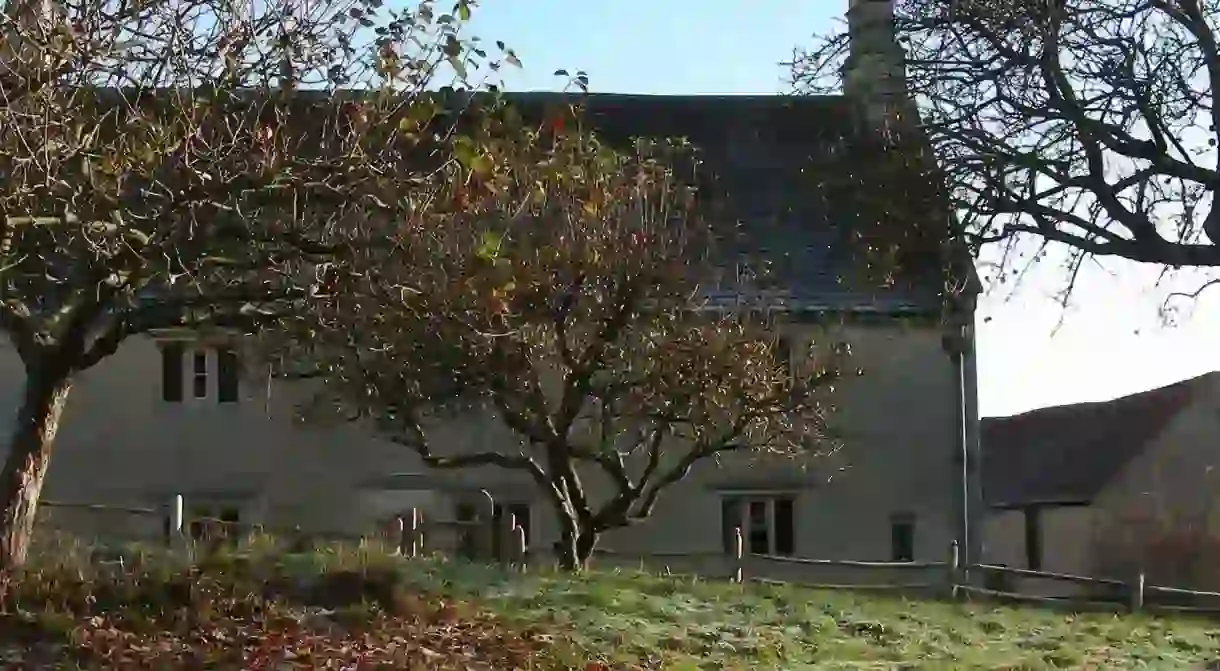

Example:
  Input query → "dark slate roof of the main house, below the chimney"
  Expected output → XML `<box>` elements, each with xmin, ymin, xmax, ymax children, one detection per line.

<box><xmin>497</xmin><ymin>93</ymin><xmax>948</xmax><ymax>312</ymax></box>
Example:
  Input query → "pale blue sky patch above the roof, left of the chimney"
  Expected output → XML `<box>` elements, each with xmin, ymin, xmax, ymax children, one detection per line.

<box><xmin>470</xmin><ymin>0</ymin><xmax>824</xmax><ymax>94</ymax></box>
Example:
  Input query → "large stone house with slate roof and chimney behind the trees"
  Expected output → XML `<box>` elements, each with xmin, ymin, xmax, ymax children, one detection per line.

<box><xmin>0</xmin><ymin>0</ymin><xmax>980</xmax><ymax>578</ymax></box>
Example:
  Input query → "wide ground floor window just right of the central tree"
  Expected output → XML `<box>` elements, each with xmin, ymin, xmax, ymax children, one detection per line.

<box><xmin>720</xmin><ymin>494</ymin><xmax>797</xmax><ymax>555</ymax></box>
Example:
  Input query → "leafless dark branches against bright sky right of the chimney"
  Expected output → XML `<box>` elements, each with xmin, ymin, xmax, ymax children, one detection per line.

<box><xmin>791</xmin><ymin>0</ymin><xmax>1220</xmax><ymax>297</ymax></box>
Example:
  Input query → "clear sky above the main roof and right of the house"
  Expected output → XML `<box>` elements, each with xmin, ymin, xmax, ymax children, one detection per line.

<box><xmin>461</xmin><ymin>0</ymin><xmax>1220</xmax><ymax>416</ymax></box>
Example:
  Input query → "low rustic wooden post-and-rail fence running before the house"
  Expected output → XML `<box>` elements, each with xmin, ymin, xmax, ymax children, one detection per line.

<box><xmin>30</xmin><ymin>495</ymin><xmax>1220</xmax><ymax>615</ymax></box>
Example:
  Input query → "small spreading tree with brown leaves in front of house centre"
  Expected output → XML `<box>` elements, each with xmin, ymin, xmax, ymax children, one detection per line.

<box><xmin>280</xmin><ymin>107</ymin><xmax>837</xmax><ymax>570</ymax></box>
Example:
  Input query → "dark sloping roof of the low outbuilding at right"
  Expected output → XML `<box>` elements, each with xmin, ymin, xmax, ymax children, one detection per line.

<box><xmin>982</xmin><ymin>372</ymin><xmax>1220</xmax><ymax>508</ymax></box>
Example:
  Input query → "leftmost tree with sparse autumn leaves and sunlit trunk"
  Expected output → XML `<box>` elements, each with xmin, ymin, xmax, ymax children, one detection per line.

<box><xmin>0</xmin><ymin>0</ymin><xmax>509</xmax><ymax>571</ymax></box>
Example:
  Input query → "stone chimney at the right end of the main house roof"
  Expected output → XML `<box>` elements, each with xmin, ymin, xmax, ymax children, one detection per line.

<box><xmin>843</xmin><ymin>0</ymin><xmax>909</xmax><ymax>131</ymax></box>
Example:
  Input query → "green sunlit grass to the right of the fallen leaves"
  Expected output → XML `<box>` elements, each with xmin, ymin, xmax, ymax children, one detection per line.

<box><xmin>412</xmin><ymin>565</ymin><xmax>1220</xmax><ymax>671</ymax></box>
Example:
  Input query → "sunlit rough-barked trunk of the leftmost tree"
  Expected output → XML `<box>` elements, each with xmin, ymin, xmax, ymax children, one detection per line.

<box><xmin>0</xmin><ymin>366</ymin><xmax>72</xmax><ymax>573</ymax></box>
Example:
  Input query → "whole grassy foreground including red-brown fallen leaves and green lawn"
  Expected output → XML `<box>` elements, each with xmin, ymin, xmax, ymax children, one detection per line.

<box><xmin>0</xmin><ymin>539</ymin><xmax>1220</xmax><ymax>671</ymax></box>
